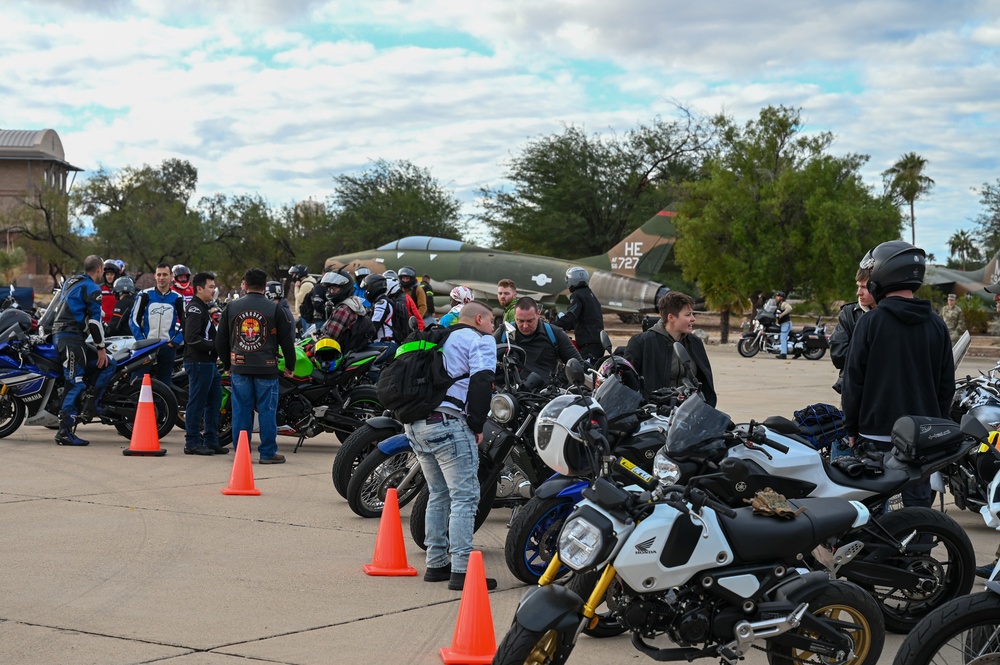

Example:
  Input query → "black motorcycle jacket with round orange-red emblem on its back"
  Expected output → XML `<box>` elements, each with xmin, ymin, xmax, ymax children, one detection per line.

<box><xmin>215</xmin><ymin>291</ymin><xmax>295</xmax><ymax>379</ymax></box>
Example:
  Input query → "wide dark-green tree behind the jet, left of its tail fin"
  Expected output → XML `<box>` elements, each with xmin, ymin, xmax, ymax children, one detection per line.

<box><xmin>480</xmin><ymin>108</ymin><xmax>713</xmax><ymax>257</ymax></box>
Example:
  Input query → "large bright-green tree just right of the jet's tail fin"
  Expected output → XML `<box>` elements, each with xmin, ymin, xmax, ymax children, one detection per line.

<box><xmin>675</xmin><ymin>106</ymin><xmax>900</xmax><ymax>342</ymax></box>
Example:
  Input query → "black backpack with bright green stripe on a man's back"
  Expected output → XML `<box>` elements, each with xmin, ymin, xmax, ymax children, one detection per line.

<box><xmin>377</xmin><ymin>327</ymin><xmax>469</xmax><ymax>423</ymax></box>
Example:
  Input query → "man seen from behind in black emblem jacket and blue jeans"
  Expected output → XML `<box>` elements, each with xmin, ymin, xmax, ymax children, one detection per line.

<box><xmin>216</xmin><ymin>268</ymin><xmax>295</xmax><ymax>464</ymax></box>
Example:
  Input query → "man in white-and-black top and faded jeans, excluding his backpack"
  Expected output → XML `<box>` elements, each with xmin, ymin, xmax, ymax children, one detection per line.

<box><xmin>398</xmin><ymin>301</ymin><xmax>496</xmax><ymax>591</ymax></box>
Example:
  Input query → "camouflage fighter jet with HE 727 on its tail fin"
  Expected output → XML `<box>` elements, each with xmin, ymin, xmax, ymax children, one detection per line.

<box><xmin>324</xmin><ymin>210</ymin><xmax>677</xmax><ymax>318</ymax></box>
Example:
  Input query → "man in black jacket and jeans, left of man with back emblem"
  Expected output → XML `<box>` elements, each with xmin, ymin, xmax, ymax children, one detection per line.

<box><xmin>184</xmin><ymin>272</ymin><xmax>229</xmax><ymax>455</ymax></box>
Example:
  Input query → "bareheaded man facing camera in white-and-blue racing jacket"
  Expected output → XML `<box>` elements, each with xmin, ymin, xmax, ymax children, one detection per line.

<box><xmin>129</xmin><ymin>263</ymin><xmax>184</xmax><ymax>387</ymax></box>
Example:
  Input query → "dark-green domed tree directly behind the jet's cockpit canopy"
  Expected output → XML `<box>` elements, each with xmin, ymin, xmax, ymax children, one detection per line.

<box><xmin>326</xmin><ymin>159</ymin><xmax>461</xmax><ymax>253</ymax></box>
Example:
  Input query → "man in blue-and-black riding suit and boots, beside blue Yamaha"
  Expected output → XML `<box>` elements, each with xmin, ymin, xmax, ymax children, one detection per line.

<box><xmin>52</xmin><ymin>255</ymin><xmax>116</xmax><ymax>446</ymax></box>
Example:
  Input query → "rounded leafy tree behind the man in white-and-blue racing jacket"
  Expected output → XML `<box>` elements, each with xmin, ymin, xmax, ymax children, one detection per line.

<box><xmin>71</xmin><ymin>159</ymin><xmax>207</xmax><ymax>274</ymax></box>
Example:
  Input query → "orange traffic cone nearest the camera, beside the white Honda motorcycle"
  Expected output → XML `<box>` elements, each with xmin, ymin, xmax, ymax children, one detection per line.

<box><xmin>441</xmin><ymin>550</ymin><xmax>497</xmax><ymax>665</ymax></box>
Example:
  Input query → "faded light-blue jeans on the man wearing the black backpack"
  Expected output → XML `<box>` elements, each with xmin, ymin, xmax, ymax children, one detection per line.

<box><xmin>406</xmin><ymin>419</ymin><xmax>479</xmax><ymax>573</ymax></box>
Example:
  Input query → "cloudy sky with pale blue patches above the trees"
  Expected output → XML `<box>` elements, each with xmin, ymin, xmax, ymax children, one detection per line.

<box><xmin>0</xmin><ymin>0</ymin><xmax>1000</xmax><ymax>261</ymax></box>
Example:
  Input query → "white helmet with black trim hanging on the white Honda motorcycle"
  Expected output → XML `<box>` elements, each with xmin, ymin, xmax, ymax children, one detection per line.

<box><xmin>535</xmin><ymin>395</ymin><xmax>608</xmax><ymax>476</ymax></box>
